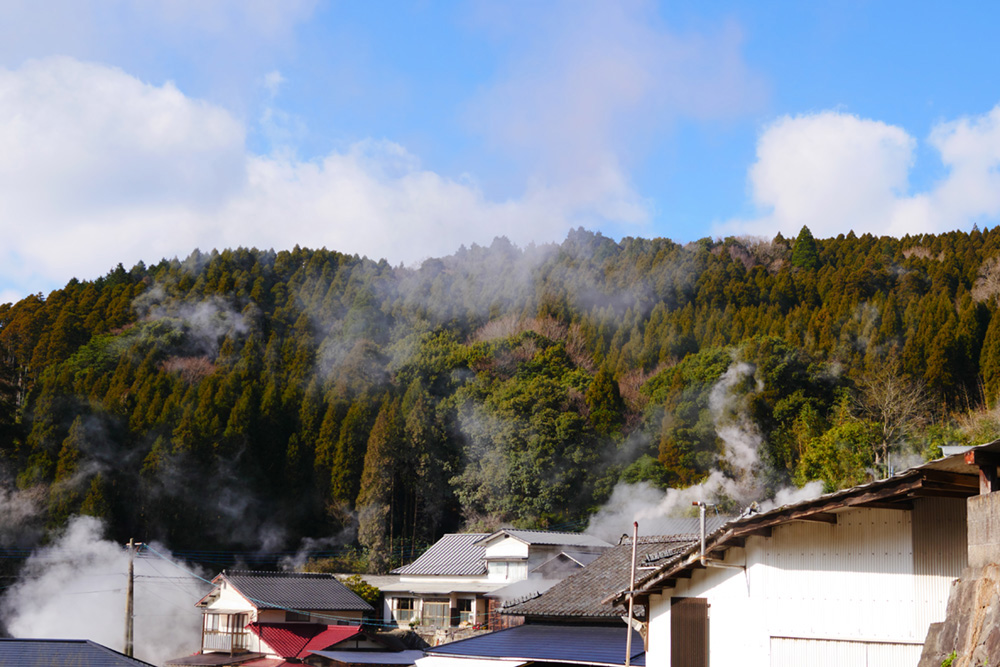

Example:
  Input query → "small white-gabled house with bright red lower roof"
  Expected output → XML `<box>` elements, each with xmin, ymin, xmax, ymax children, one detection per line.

<box><xmin>167</xmin><ymin>571</ymin><xmax>378</xmax><ymax>666</ymax></box>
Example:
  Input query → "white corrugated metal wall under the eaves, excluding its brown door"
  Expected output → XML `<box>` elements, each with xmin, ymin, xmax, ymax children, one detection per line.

<box><xmin>646</xmin><ymin>498</ymin><xmax>966</xmax><ymax>667</ymax></box>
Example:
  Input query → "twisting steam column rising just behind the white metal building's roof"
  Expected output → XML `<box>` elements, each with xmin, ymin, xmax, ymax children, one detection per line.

<box><xmin>586</xmin><ymin>362</ymin><xmax>823</xmax><ymax>541</ymax></box>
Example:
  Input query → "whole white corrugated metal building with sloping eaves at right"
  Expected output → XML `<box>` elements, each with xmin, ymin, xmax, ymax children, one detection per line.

<box><xmin>608</xmin><ymin>441</ymin><xmax>1000</xmax><ymax>667</ymax></box>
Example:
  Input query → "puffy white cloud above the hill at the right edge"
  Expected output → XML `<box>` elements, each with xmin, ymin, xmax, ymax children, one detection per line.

<box><xmin>715</xmin><ymin>107</ymin><xmax>1000</xmax><ymax>243</ymax></box>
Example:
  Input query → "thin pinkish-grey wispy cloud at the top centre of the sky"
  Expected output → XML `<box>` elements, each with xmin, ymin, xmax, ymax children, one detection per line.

<box><xmin>467</xmin><ymin>1</ymin><xmax>765</xmax><ymax>236</ymax></box>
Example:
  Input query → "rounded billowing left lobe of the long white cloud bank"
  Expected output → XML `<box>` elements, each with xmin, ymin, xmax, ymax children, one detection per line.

<box><xmin>0</xmin><ymin>58</ymin><xmax>246</xmax><ymax>291</ymax></box>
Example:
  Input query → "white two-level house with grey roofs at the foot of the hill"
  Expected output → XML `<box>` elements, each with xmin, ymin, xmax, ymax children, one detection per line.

<box><xmin>382</xmin><ymin>529</ymin><xmax>611</xmax><ymax>628</ymax></box>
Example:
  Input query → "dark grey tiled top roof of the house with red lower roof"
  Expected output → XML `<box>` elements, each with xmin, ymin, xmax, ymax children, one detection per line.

<box><xmin>220</xmin><ymin>570</ymin><xmax>373</xmax><ymax>611</ymax></box>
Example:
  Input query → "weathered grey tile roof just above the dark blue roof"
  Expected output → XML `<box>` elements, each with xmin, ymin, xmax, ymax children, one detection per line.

<box><xmin>503</xmin><ymin>535</ymin><xmax>698</xmax><ymax>619</ymax></box>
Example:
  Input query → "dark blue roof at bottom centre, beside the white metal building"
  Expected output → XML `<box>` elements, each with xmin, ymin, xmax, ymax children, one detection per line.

<box><xmin>426</xmin><ymin>624</ymin><xmax>644</xmax><ymax>665</ymax></box>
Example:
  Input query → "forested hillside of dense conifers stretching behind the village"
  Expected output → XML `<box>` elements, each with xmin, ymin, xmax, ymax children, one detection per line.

<box><xmin>0</xmin><ymin>229</ymin><xmax>1000</xmax><ymax>570</ymax></box>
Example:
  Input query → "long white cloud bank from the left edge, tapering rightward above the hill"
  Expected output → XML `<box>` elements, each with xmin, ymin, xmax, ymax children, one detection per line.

<box><xmin>0</xmin><ymin>58</ymin><xmax>590</xmax><ymax>294</ymax></box>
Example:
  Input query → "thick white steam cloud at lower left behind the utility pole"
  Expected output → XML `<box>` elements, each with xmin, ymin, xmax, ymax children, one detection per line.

<box><xmin>0</xmin><ymin>516</ymin><xmax>209</xmax><ymax>664</ymax></box>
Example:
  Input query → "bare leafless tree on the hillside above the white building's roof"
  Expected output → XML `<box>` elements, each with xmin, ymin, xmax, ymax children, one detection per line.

<box><xmin>856</xmin><ymin>357</ymin><xmax>928</xmax><ymax>475</ymax></box>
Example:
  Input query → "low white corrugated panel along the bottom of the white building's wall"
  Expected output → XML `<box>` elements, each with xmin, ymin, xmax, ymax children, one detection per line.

<box><xmin>771</xmin><ymin>637</ymin><xmax>923</xmax><ymax>667</ymax></box>
